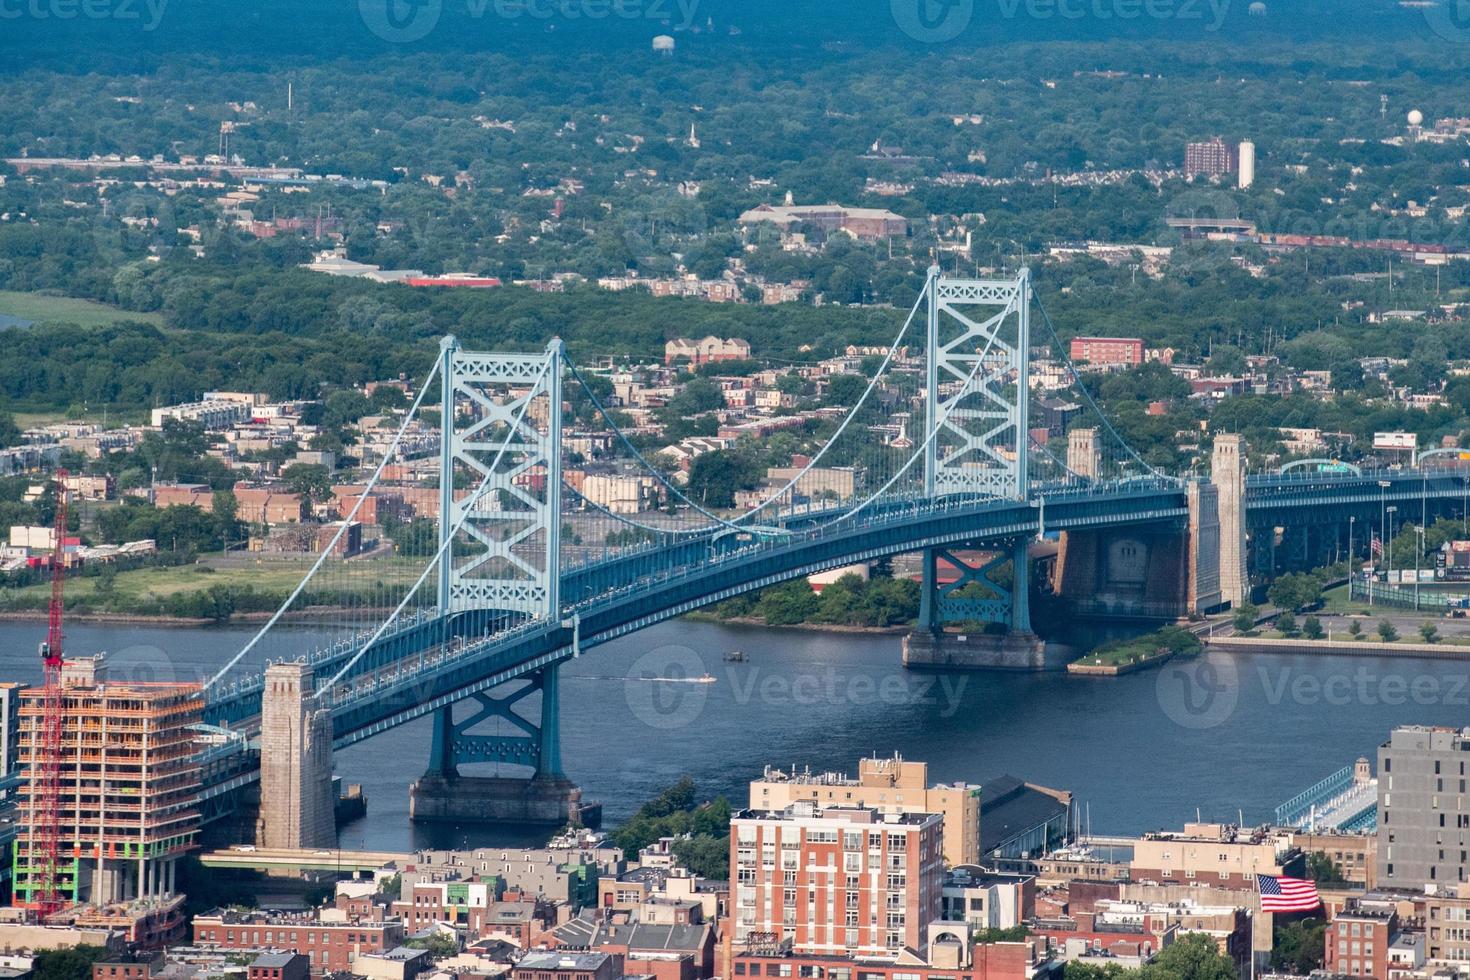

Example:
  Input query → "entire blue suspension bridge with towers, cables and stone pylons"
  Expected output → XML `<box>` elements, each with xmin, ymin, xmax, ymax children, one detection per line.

<box><xmin>163</xmin><ymin>269</ymin><xmax>1467</xmax><ymax>848</ymax></box>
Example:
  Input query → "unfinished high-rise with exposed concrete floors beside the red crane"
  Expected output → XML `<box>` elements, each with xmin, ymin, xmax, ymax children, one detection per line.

<box><xmin>15</xmin><ymin>657</ymin><xmax>204</xmax><ymax>942</ymax></box>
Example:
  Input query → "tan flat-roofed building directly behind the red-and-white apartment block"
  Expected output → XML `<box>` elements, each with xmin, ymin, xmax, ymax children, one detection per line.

<box><xmin>750</xmin><ymin>754</ymin><xmax>980</xmax><ymax>867</ymax></box>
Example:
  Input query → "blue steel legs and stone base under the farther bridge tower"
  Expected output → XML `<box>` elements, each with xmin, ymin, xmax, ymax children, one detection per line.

<box><xmin>903</xmin><ymin>536</ymin><xmax>1047</xmax><ymax>670</ymax></box>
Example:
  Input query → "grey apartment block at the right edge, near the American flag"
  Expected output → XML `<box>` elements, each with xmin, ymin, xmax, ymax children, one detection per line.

<box><xmin>1377</xmin><ymin>726</ymin><xmax>1470</xmax><ymax>889</ymax></box>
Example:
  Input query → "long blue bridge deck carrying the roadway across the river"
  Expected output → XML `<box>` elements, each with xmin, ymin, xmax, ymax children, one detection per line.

<box><xmin>189</xmin><ymin>469</ymin><xmax>1470</xmax><ymax>798</ymax></box>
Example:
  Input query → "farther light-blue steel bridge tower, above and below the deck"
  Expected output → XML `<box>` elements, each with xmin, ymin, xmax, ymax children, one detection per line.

<box><xmin>919</xmin><ymin>266</ymin><xmax>1030</xmax><ymax>633</ymax></box>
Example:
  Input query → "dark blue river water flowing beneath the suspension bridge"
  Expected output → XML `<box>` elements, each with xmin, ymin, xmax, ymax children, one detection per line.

<box><xmin>0</xmin><ymin>621</ymin><xmax>1470</xmax><ymax>849</ymax></box>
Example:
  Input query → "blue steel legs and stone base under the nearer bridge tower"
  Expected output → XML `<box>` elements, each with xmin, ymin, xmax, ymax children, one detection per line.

<box><xmin>409</xmin><ymin>664</ymin><xmax>603</xmax><ymax>827</ymax></box>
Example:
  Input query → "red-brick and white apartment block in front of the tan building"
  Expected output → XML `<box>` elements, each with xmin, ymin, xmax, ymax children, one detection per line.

<box><xmin>731</xmin><ymin>802</ymin><xmax>944</xmax><ymax>958</ymax></box>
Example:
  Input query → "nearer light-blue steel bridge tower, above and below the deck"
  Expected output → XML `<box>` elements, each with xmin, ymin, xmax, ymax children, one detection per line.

<box><xmin>428</xmin><ymin>336</ymin><xmax>563</xmax><ymax>779</ymax></box>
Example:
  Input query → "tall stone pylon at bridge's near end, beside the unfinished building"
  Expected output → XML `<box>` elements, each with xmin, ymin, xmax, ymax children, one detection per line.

<box><xmin>256</xmin><ymin>664</ymin><xmax>337</xmax><ymax>848</ymax></box>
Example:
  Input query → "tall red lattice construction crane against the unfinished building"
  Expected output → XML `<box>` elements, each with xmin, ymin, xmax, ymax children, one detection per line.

<box><xmin>29</xmin><ymin>470</ymin><xmax>66</xmax><ymax>921</ymax></box>
